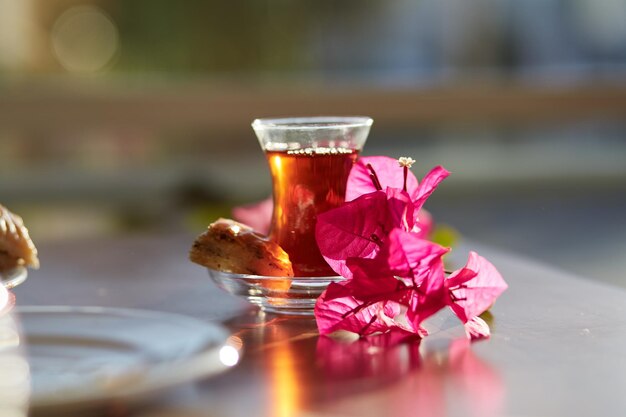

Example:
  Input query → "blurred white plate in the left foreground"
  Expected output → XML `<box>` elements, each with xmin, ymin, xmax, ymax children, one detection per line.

<box><xmin>16</xmin><ymin>307</ymin><xmax>238</xmax><ymax>412</ymax></box>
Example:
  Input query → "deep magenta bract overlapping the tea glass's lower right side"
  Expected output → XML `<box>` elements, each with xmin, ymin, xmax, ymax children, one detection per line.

<box><xmin>315</xmin><ymin>192</ymin><xmax>393</xmax><ymax>278</ymax></box>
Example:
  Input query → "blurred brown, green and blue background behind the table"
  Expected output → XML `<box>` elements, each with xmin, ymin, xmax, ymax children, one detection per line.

<box><xmin>0</xmin><ymin>0</ymin><xmax>626</xmax><ymax>287</ymax></box>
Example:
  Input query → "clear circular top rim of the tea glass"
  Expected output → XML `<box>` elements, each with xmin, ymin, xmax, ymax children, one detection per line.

<box><xmin>252</xmin><ymin>116</ymin><xmax>374</xmax><ymax>130</ymax></box>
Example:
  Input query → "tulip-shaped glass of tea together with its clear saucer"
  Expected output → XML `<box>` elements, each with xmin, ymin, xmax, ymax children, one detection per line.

<box><xmin>209</xmin><ymin>117</ymin><xmax>372</xmax><ymax>315</ymax></box>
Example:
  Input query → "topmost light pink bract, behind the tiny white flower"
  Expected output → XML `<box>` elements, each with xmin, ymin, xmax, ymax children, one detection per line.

<box><xmin>346</xmin><ymin>156</ymin><xmax>417</xmax><ymax>201</ymax></box>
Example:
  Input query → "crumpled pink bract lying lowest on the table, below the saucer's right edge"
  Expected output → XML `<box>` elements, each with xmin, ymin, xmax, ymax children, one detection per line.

<box><xmin>315</xmin><ymin>283</ymin><xmax>400</xmax><ymax>336</ymax></box>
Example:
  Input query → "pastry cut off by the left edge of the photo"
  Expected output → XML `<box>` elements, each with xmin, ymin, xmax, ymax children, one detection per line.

<box><xmin>0</xmin><ymin>204</ymin><xmax>39</xmax><ymax>273</ymax></box>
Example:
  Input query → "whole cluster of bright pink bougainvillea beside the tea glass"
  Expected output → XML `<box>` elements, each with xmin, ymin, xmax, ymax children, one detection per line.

<box><xmin>315</xmin><ymin>157</ymin><xmax>507</xmax><ymax>338</ymax></box>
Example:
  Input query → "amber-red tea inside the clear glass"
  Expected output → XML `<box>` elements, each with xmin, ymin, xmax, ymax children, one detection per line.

<box><xmin>266</xmin><ymin>148</ymin><xmax>358</xmax><ymax>277</ymax></box>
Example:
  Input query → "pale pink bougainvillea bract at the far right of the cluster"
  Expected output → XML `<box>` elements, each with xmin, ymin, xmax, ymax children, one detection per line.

<box><xmin>446</xmin><ymin>252</ymin><xmax>508</xmax><ymax>323</ymax></box>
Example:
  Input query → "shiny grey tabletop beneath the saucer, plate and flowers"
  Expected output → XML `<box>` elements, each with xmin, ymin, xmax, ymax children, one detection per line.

<box><xmin>7</xmin><ymin>235</ymin><xmax>626</xmax><ymax>417</ymax></box>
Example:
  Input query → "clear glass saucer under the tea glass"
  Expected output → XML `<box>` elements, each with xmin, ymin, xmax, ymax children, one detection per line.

<box><xmin>207</xmin><ymin>268</ymin><xmax>345</xmax><ymax>316</ymax></box>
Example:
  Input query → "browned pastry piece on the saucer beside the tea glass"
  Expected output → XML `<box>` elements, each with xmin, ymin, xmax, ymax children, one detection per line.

<box><xmin>189</xmin><ymin>219</ymin><xmax>293</xmax><ymax>277</ymax></box>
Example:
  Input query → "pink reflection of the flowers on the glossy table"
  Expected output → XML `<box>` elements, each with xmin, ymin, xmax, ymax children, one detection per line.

<box><xmin>316</xmin><ymin>332</ymin><xmax>506</xmax><ymax>417</ymax></box>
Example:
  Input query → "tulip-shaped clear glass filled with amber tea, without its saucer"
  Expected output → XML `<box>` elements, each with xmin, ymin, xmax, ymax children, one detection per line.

<box><xmin>252</xmin><ymin>117</ymin><xmax>372</xmax><ymax>277</ymax></box>
